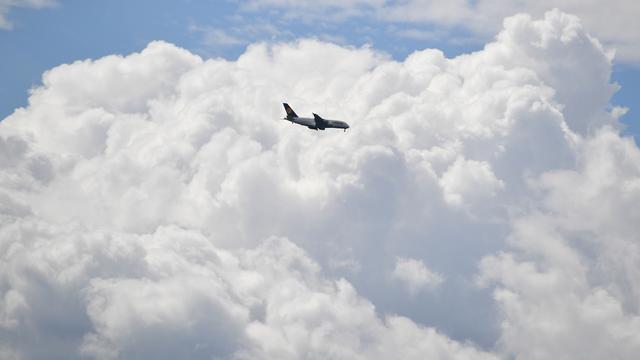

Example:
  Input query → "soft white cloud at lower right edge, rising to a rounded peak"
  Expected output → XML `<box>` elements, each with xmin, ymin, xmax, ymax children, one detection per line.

<box><xmin>479</xmin><ymin>129</ymin><xmax>640</xmax><ymax>359</ymax></box>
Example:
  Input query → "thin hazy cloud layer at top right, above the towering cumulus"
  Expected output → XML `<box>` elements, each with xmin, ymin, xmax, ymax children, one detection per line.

<box><xmin>247</xmin><ymin>0</ymin><xmax>640</xmax><ymax>63</ymax></box>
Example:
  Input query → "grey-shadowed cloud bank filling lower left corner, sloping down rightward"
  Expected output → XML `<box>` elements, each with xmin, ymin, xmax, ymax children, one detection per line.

<box><xmin>2</xmin><ymin>220</ymin><xmax>494</xmax><ymax>359</ymax></box>
